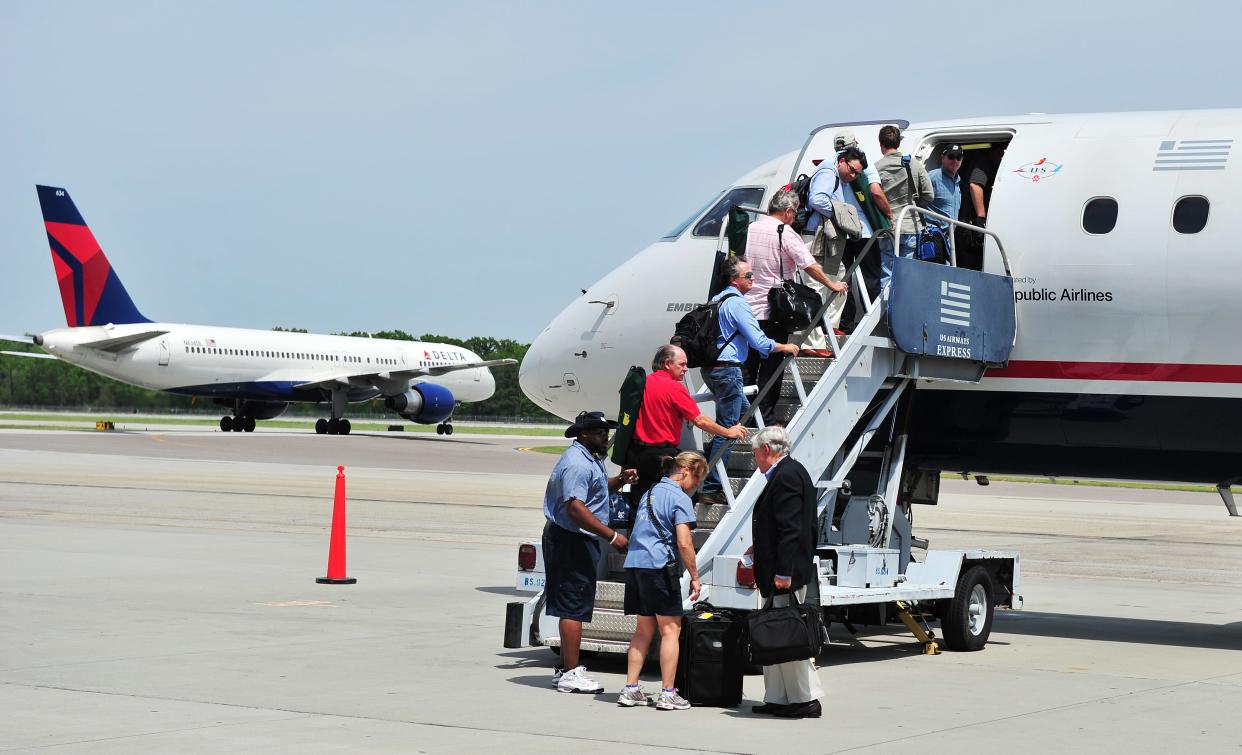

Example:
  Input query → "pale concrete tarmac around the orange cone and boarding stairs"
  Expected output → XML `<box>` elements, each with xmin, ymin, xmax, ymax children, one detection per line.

<box><xmin>0</xmin><ymin>430</ymin><xmax>1242</xmax><ymax>754</ymax></box>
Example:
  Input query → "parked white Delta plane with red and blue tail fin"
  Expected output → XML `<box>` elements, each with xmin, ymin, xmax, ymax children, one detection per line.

<box><xmin>2</xmin><ymin>186</ymin><xmax>517</xmax><ymax>435</ymax></box>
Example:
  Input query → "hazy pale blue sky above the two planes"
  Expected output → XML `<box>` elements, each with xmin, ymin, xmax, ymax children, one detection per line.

<box><xmin>0</xmin><ymin>0</ymin><xmax>1242</xmax><ymax>341</ymax></box>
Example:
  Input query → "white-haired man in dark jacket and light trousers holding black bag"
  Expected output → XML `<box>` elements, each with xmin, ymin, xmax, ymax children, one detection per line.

<box><xmin>748</xmin><ymin>426</ymin><xmax>823</xmax><ymax>718</ymax></box>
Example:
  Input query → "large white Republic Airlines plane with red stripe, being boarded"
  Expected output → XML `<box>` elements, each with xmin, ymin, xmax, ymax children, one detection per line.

<box><xmin>520</xmin><ymin>109</ymin><xmax>1242</xmax><ymax>504</ymax></box>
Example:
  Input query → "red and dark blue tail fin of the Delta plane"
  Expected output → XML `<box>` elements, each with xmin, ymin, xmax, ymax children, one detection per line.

<box><xmin>35</xmin><ymin>186</ymin><xmax>150</xmax><ymax>328</ymax></box>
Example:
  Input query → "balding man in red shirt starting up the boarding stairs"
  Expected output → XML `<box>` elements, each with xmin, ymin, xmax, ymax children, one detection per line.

<box><xmin>626</xmin><ymin>344</ymin><xmax>746</xmax><ymax>509</ymax></box>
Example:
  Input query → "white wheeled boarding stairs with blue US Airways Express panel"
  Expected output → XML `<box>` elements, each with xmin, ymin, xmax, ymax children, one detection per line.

<box><xmin>505</xmin><ymin>207</ymin><xmax>1021</xmax><ymax>652</ymax></box>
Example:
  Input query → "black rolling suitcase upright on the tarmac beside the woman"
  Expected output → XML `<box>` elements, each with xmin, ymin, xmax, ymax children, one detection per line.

<box><xmin>677</xmin><ymin>604</ymin><xmax>746</xmax><ymax>708</ymax></box>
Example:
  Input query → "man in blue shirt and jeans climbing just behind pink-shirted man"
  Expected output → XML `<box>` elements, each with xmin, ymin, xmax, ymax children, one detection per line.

<box><xmin>699</xmin><ymin>257</ymin><xmax>797</xmax><ymax>503</ymax></box>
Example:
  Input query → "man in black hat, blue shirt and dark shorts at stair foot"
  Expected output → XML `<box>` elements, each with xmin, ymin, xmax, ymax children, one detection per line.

<box><xmin>543</xmin><ymin>411</ymin><xmax>638</xmax><ymax>694</ymax></box>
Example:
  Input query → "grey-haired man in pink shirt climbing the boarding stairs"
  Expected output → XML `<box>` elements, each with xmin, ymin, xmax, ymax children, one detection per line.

<box><xmin>745</xmin><ymin>189</ymin><xmax>848</xmax><ymax>416</ymax></box>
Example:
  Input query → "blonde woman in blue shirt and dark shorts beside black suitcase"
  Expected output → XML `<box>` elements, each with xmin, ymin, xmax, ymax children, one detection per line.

<box><xmin>617</xmin><ymin>451</ymin><xmax>707</xmax><ymax>710</ymax></box>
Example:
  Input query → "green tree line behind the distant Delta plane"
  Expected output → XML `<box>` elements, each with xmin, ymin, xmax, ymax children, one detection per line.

<box><xmin>0</xmin><ymin>327</ymin><xmax>559</xmax><ymax>422</ymax></box>
